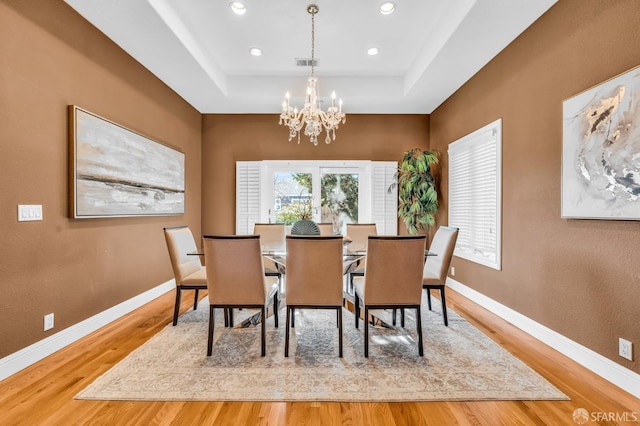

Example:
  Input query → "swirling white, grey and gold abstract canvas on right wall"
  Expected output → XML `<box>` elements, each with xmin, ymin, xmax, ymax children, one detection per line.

<box><xmin>562</xmin><ymin>67</ymin><xmax>640</xmax><ymax>220</ymax></box>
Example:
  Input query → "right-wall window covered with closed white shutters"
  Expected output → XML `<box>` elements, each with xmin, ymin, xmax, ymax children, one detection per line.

<box><xmin>449</xmin><ymin>119</ymin><xmax>502</xmax><ymax>270</ymax></box>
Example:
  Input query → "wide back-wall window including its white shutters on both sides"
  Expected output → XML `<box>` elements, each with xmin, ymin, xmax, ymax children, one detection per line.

<box><xmin>236</xmin><ymin>160</ymin><xmax>398</xmax><ymax>235</ymax></box>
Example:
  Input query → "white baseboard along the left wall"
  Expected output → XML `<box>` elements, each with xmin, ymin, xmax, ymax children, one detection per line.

<box><xmin>0</xmin><ymin>279</ymin><xmax>176</xmax><ymax>380</ymax></box>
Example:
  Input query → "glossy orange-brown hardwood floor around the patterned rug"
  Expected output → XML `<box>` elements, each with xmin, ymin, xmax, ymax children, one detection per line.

<box><xmin>0</xmin><ymin>289</ymin><xmax>640</xmax><ymax>426</ymax></box>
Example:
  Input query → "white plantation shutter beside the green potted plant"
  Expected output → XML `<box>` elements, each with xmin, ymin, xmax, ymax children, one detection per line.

<box><xmin>371</xmin><ymin>161</ymin><xmax>398</xmax><ymax>235</ymax></box>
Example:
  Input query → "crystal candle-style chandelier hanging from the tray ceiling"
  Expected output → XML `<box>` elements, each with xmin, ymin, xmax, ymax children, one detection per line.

<box><xmin>280</xmin><ymin>4</ymin><xmax>347</xmax><ymax>145</ymax></box>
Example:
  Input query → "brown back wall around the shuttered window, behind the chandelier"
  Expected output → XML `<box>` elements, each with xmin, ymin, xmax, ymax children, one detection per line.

<box><xmin>202</xmin><ymin>114</ymin><xmax>429</xmax><ymax>234</ymax></box>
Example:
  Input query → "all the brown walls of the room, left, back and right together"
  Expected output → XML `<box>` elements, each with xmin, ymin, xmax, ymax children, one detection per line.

<box><xmin>0</xmin><ymin>0</ymin><xmax>640</xmax><ymax>382</ymax></box>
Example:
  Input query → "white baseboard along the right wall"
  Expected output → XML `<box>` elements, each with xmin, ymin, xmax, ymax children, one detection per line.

<box><xmin>447</xmin><ymin>278</ymin><xmax>640</xmax><ymax>398</ymax></box>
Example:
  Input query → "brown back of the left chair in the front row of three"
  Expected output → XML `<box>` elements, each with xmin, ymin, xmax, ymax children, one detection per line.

<box><xmin>204</xmin><ymin>235</ymin><xmax>266</xmax><ymax>305</ymax></box>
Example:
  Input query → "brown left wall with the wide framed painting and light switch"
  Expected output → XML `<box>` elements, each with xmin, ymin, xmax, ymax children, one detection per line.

<box><xmin>0</xmin><ymin>0</ymin><xmax>201</xmax><ymax>358</ymax></box>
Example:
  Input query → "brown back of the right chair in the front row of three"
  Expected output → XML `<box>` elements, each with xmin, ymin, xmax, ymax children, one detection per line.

<box><xmin>364</xmin><ymin>235</ymin><xmax>427</xmax><ymax>305</ymax></box>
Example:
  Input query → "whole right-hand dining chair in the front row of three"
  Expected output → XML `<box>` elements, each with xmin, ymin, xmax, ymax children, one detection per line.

<box><xmin>354</xmin><ymin>235</ymin><xmax>426</xmax><ymax>357</ymax></box>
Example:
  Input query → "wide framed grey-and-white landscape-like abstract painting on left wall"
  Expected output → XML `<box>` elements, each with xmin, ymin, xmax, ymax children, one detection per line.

<box><xmin>68</xmin><ymin>105</ymin><xmax>185</xmax><ymax>218</ymax></box>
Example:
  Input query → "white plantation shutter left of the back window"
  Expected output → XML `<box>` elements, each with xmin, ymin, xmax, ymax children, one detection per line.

<box><xmin>236</xmin><ymin>161</ymin><xmax>261</xmax><ymax>235</ymax></box>
